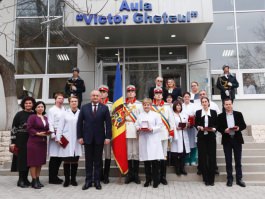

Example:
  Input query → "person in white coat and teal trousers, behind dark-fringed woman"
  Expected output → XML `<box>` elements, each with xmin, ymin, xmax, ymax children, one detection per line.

<box><xmin>182</xmin><ymin>92</ymin><xmax>198</xmax><ymax>166</ymax></box>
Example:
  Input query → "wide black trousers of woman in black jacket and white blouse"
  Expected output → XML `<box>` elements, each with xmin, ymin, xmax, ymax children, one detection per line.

<box><xmin>198</xmin><ymin>133</ymin><xmax>216</xmax><ymax>183</ymax></box>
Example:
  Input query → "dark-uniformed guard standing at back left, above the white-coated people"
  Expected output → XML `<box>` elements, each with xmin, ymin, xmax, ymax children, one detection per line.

<box><xmin>64</xmin><ymin>67</ymin><xmax>86</xmax><ymax>109</ymax></box>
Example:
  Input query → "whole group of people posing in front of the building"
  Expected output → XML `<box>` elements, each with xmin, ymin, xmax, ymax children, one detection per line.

<box><xmin>11</xmin><ymin>66</ymin><xmax>246</xmax><ymax>190</ymax></box>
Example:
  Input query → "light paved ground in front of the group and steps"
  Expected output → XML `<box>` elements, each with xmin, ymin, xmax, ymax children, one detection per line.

<box><xmin>0</xmin><ymin>176</ymin><xmax>265</xmax><ymax>199</ymax></box>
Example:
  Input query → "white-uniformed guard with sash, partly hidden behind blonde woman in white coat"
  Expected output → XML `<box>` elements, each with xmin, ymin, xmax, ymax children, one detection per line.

<box><xmin>152</xmin><ymin>88</ymin><xmax>174</xmax><ymax>185</ymax></box>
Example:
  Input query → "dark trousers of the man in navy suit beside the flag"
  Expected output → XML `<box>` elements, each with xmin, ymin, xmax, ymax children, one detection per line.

<box><xmin>85</xmin><ymin>143</ymin><xmax>104</xmax><ymax>183</ymax></box>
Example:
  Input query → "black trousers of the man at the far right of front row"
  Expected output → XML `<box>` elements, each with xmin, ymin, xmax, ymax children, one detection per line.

<box><xmin>223</xmin><ymin>138</ymin><xmax>242</xmax><ymax>180</ymax></box>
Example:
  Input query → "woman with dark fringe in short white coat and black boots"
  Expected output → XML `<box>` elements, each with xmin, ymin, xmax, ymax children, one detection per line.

<box><xmin>171</xmin><ymin>101</ymin><xmax>190</xmax><ymax>175</ymax></box>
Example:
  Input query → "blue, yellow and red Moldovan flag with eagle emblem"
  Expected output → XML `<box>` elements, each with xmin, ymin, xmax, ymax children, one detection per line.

<box><xmin>112</xmin><ymin>63</ymin><xmax>128</xmax><ymax>174</ymax></box>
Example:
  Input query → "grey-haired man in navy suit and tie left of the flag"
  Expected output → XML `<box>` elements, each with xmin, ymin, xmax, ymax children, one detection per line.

<box><xmin>77</xmin><ymin>90</ymin><xmax>112</xmax><ymax>190</ymax></box>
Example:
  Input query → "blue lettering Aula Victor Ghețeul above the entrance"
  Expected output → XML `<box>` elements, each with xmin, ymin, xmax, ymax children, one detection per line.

<box><xmin>76</xmin><ymin>0</ymin><xmax>198</xmax><ymax>25</ymax></box>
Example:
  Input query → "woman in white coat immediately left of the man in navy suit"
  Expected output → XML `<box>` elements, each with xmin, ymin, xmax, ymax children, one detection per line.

<box><xmin>56</xmin><ymin>96</ymin><xmax>82</xmax><ymax>187</ymax></box>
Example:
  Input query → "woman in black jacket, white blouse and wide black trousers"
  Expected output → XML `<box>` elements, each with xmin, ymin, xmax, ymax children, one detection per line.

<box><xmin>195</xmin><ymin>97</ymin><xmax>217</xmax><ymax>186</ymax></box>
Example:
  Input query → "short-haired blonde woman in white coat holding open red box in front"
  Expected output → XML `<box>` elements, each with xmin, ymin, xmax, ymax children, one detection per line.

<box><xmin>135</xmin><ymin>98</ymin><xmax>164</xmax><ymax>188</ymax></box>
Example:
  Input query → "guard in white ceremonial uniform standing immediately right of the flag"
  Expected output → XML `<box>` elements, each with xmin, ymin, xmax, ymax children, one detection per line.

<box><xmin>124</xmin><ymin>85</ymin><xmax>142</xmax><ymax>184</ymax></box>
